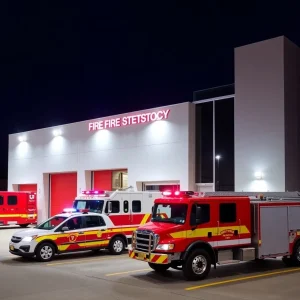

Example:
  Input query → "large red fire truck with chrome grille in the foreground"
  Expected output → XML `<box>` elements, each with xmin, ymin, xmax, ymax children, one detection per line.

<box><xmin>129</xmin><ymin>191</ymin><xmax>300</xmax><ymax>280</ymax></box>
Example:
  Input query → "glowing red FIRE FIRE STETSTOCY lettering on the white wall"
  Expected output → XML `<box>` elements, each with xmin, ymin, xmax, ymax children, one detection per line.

<box><xmin>89</xmin><ymin>109</ymin><xmax>170</xmax><ymax>131</ymax></box>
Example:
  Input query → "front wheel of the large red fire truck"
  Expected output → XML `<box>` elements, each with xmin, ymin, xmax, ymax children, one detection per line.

<box><xmin>182</xmin><ymin>249</ymin><xmax>211</xmax><ymax>280</ymax></box>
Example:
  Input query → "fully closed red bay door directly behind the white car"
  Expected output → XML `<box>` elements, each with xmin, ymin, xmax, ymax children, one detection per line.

<box><xmin>49</xmin><ymin>173</ymin><xmax>77</xmax><ymax>216</ymax></box>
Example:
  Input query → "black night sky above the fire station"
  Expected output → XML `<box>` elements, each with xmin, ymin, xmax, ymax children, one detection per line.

<box><xmin>0</xmin><ymin>0</ymin><xmax>300</xmax><ymax>177</ymax></box>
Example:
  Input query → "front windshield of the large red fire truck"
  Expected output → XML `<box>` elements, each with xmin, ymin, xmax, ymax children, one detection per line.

<box><xmin>151</xmin><ymin>203</ymin><xmax>187</xmax><ymax>224</ymax></box>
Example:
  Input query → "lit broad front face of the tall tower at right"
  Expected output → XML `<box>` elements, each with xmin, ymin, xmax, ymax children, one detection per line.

<box><xmin>235</xmin><ymin>37</ymin><xmax>285</xmax><ymax>192</ymax></box>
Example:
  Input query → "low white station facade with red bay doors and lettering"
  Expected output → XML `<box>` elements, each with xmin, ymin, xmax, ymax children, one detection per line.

<box><xmin>8</xmin><ymin>102</ymin><xmax>195</xmax><ymax>218</ymax></box>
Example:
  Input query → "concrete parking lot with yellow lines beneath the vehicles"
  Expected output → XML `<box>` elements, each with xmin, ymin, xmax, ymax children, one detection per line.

<box><xmin>0</xmin><ymin>227</ymin><xmax>300</xmax><ymax>300</ymax></box>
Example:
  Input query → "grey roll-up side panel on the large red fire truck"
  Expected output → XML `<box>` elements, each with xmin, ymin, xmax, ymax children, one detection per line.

<box><xmin>259</xmin><ymin>206</ymin><xmax>289</xmax><ymax>256</ymax></box>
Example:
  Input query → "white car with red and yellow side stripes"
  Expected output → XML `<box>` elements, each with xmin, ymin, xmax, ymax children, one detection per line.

<box><xmin>9</xmin><ymin>210</ymin><xmax>133</xmax><ymax>262</ymax></box>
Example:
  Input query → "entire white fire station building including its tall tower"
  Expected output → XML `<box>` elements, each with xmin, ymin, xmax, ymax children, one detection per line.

<box><xmin>8</xmin><ymin>37</ymin><xmax>300</xmax><ymax>219</ymax></box>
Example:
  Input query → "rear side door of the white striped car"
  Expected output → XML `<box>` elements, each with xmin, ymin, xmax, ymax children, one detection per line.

<box><xmin>83</xmin><ymin>215</ymin><xmax>109</xmax><ymax>249</ymax></box>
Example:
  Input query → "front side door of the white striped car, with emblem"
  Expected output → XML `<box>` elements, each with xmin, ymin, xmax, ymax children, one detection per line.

<box><xmin>56</xmin><ymin>216</ymin><xmax>87</xmax><ymax>251</ymax></box>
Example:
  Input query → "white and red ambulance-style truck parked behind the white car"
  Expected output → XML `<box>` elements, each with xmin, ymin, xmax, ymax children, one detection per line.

<box><xmin>65</xmin><ymin>189</ymin><xmax>161</xmax><ymax>240</ymax></box>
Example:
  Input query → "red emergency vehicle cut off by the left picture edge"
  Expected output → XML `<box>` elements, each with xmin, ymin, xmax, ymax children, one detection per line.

<box><xmin>0</xmin><ymin>191</ymin><xmax>37</xmax><ymax>227</ymax></box>
